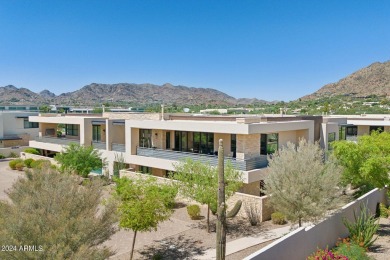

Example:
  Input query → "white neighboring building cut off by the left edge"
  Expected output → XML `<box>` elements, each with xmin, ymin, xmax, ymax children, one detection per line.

<box><xmin>0</xmin><ymin>111</ymin><xmax>39</xmax><ymax>148</ymax></box>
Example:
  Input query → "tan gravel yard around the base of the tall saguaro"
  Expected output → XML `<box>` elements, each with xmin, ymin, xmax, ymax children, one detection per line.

<box><xmin>112</xmin><ymin>203</ymin><xmax>288</xmax><ymax>260</ymax></box>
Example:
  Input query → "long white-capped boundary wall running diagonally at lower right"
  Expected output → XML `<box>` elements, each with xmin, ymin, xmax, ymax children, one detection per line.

<box><xmin>245</xmin><ymin>189</ymin><xmax>387</xmax><ymax>260</ymax></box>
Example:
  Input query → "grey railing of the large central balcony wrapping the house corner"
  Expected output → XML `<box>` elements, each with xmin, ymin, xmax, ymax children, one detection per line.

<box><xmin>137</xmin><ymin>147</ymin><xmax>268</xmax><ymax>171</ymax></box>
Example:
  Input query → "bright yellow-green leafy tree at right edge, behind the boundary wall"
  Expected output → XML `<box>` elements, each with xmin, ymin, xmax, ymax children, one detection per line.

<box><xmin>332</xmin><ymin>131</ymin><xmax>390</xmax><ymax>188</ymax></box>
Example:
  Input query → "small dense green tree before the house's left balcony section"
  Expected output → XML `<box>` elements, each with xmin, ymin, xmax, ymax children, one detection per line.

<box><xmin>54</xmin><ymin>143</ymin><xmax>104</xmax><ymax>177</ymax></box>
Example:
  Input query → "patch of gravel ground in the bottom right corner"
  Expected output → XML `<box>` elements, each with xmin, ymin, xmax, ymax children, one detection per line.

<box><xmin>368</xmin><ymin>218</ymin><xmax>390</xmax><ymax>260</ymax></box>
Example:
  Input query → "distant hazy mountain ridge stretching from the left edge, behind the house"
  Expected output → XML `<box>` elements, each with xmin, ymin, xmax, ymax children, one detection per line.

<box><xmin>0</xmin><ymin>83</ymin><xmax>267</xmax><ymax>106</ymax></box>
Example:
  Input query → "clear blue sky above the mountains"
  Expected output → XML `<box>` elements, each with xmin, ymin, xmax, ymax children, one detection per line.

<box><xmin>0</xmin><ymin>0</ymin><xmax>390</xmax><ymax>101</ymax></box>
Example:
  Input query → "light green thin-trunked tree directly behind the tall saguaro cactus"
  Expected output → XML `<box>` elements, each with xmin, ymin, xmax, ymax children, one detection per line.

<box><xmin>171</xmin><ymin>159</ymin><xmax>242</xmax><ymax>232</ymax></box>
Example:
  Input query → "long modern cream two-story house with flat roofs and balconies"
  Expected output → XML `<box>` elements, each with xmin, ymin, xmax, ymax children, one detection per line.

<box><xmin>30</xmin><ymin>113</ymin><xmax>390</xmax><ymax>195</ymax></box>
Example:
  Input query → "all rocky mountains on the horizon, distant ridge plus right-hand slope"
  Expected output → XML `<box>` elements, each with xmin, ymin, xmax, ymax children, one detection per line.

<box><xmin>0</xmin><ymin>61</ymin><xmax>390</xmax><ymax>106</ymax></box>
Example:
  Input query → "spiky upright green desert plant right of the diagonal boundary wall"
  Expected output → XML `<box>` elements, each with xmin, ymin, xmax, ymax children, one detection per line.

<box><xmin>343</xmin><ymin>204</ymin><xmax>379</xmax><ymax>248</ymax></box>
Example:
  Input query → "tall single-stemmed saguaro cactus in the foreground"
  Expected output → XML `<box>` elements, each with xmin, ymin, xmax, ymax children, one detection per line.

<box><xmin>216</xmin><ymin>139</ymin><xmax>226</xmax><ymax>260</ymax></box>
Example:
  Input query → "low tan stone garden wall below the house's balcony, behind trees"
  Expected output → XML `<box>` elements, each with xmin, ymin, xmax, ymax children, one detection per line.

<box><xmin>119</xmin><ymin>170</ymin><xmax>273</xmax><ymax>222</ymax></box>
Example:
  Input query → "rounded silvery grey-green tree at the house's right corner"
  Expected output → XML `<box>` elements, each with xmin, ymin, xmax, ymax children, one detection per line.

<box><xmin>266</xmin><ymin>139</ymin><xmax>341</xmax><ymax>226</ymax></box>
